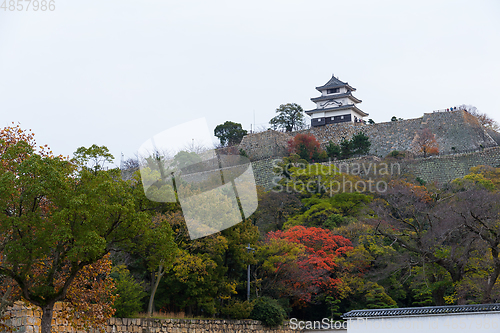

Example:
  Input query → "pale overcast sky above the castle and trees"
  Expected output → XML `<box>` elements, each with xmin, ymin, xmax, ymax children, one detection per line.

<box><xmin>0</xmin><ymin>0</ymin><xmax>500</xmax><ymax>163</ymax></box>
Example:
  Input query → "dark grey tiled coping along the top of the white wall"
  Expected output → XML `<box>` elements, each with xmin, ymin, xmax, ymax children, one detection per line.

<box><xmin>343</xmin><ymin>303</ymin><xmax>500</xmax><ymax>318</ymax></box>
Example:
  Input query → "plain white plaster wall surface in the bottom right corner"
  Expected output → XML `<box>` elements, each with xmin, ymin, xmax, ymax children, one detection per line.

<box><xmin>347</xmin><ymin>312</ymin><xmax>500</xmax><ymax>333</ymax></box>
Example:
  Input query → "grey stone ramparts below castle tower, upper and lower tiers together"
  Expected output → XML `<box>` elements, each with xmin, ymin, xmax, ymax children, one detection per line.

<box><xmin>239</xmin><ymin>110</ymin><xmax>500</xmax><ymax>190</ymax></box>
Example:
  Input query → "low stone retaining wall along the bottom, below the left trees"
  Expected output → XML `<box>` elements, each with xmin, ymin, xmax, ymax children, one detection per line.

<box><xmin>2</xmin><ymin>302</ymin><xmax>302</xmax><ymax>333</ymax></box>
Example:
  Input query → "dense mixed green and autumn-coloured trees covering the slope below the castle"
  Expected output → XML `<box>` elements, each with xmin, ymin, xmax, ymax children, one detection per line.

<box><xmin>0</xmin><ymin>120</ymin><xmax>500</xmax><ymax>333</ymax></box>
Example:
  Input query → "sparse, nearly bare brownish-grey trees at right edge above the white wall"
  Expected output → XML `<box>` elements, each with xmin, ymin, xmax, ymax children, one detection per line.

<box><xmin>371</xmin><ymin>176</ymin><xmax>500</xmax><ymax>305</ymax></box>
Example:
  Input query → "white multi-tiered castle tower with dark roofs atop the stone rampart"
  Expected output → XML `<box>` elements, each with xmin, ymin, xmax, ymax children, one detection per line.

<box><xmin>306</xmin><ymin>75</ymin><xmax>368</xmax><ymax>127</ymax></box>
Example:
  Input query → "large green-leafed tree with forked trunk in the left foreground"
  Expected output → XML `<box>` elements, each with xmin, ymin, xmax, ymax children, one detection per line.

<box><xmin>0</xmin><ymin>128</ymin><xmax>159</xmax><ymax>333</ymax></box>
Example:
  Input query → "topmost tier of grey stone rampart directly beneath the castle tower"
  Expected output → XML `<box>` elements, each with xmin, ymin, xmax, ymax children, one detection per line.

<box><xmin>240</xmin><ymin>110</ymin><xmax>500</xmax><ymax>160</ymax></box>
